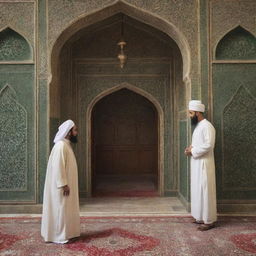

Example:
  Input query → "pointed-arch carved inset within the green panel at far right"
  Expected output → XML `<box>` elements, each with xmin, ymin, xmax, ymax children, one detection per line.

<box><xmin>222</xmin><ymin>86</ymin><xmax>256</xmax><ymax>190</ymax></box>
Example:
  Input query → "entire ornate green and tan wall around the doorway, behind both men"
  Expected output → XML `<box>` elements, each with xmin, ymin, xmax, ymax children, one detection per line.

<box><xmin>0</xmin><ymin>0</ymin><xmax>256</xmax><ymax>212</ymax></box>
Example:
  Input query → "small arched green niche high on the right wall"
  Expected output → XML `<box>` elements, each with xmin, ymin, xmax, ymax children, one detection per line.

<box><xmin>215</xmin><ymin>26</ymin><xmax>256</xmax><ymax>60</ymax></box>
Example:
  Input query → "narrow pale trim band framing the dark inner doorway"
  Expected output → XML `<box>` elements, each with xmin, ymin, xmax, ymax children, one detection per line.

<box><xmin>86</xmin><ymin>83</ymin><xmax>164</xmax><ymax>195</ymax></box>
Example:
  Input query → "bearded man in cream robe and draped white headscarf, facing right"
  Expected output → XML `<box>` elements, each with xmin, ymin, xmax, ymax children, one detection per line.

<box><xmin>41</xmin><ymin>120</ymin><xmax>80</xmax><ymax>244</ymax></box>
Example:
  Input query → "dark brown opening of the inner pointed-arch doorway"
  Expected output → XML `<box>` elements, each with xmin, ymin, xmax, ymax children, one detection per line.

<box><xmin>91</xmin><ymin>88</ymin><xmax>159</xmax><ymax>196</ymax></box>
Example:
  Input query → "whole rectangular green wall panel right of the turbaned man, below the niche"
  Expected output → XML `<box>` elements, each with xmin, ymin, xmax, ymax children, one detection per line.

<box><xmin>213</xmin><ymin>63</ymin><xmax>256</xmax><ymax>200</ymax></box>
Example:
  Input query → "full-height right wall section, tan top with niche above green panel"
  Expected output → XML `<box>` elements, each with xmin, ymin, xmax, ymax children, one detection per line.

<box><xmin>210</xmin><ymin>0</ymin><xmax>256</xmax><ymax>202</ymax></box>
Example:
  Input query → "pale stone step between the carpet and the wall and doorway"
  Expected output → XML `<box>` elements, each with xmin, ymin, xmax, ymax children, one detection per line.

<box><xmin>0</xmin><ymin>197</ymin><xmax>189</xmax><ymax>217</ymax></box>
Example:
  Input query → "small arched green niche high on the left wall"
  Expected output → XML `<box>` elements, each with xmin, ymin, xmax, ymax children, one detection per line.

<box><xmin>0</xmin><ymin>27</ymin><xmax>33</xmax><ymax>62</ymax></box>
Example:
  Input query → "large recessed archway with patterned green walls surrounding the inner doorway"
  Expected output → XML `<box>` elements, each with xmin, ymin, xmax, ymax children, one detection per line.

<box><xmin>50</xmin><ymin>3</ymin><xmax>190</xmax><ymax>197</ymax></box>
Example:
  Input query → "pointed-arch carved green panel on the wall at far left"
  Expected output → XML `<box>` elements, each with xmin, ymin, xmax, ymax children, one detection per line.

<box><xmin>0</xmin><ymin>85</ymin><xmax>28</xmax><ymax>191</ymax></box>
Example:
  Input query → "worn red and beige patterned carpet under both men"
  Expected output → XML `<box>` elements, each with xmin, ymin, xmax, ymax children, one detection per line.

<box><xmin>0</xmin><ymin>217</ymin><xmax>256</xmax><ymax>256</ymax></box>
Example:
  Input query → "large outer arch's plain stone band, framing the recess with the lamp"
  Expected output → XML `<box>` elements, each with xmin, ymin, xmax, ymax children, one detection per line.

<box><xmin>50</xmin><ymin>1</ymin><xmax>191</xmax><ymax>116</ymax></box>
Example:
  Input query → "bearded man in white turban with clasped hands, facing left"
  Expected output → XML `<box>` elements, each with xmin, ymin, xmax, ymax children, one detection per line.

<box><xmin>185</xmin><ymin>100</ymin><xmax>217</xmax><ymax>231</ymax></box>
